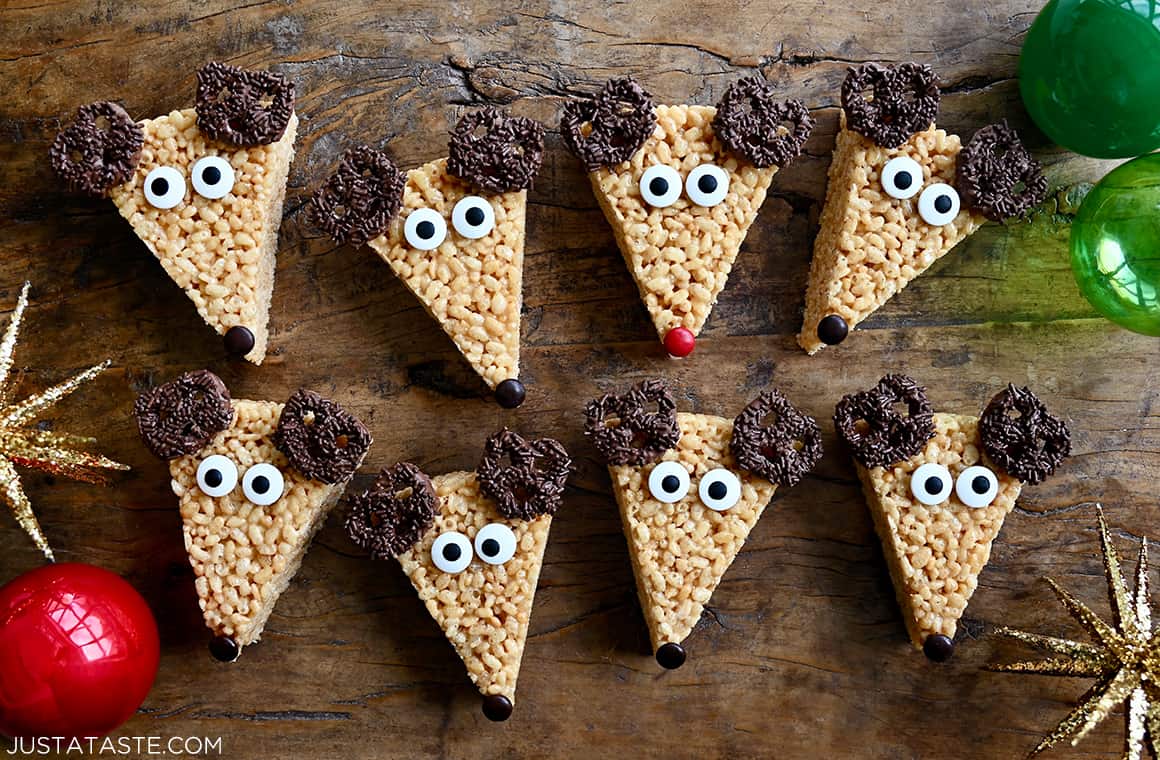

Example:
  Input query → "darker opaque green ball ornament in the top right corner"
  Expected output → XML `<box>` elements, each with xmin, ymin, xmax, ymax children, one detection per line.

<box><xmin>1018</xmin><ymin>0</ymin><xmax>1160</xmax><ymax>158</ymax></box>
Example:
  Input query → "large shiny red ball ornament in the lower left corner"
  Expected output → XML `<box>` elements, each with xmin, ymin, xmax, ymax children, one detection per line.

<box><xmin>0</xmin><ymin>563</ymin><xmax>160</xmax><ymax>739</ymax></box>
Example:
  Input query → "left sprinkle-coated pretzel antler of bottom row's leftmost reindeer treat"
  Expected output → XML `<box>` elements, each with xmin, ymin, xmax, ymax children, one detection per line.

<box><xmin>133</xmin><ymin>369</ymin><xmax>233</xmax><ymax>459</ymax></box>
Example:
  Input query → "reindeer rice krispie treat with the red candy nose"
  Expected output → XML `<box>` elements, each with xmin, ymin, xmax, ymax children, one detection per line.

<box><xmin>560</xmin><ymin>77</ymin><xmax>813</xmax><ymax>356</ymax></box>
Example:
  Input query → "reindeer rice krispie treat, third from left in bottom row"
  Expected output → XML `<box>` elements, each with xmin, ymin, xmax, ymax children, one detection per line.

<box><xmin>585</xmin><ymin>381</ymin><xmax>821</xmax><ymax>668</ymax></box>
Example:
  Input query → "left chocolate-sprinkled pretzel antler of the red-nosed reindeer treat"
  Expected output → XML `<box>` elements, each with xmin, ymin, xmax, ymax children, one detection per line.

<box><xmin>560</xmin><ymin>77</ymin><xmax>657</xmax><ymax>172</ymax></box>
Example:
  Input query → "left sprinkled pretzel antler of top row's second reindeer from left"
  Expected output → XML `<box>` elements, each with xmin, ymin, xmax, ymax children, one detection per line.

<box><xmin>306</xmin><ymin>145</ymin><xmax>407</xmax><ymax>246</ymax></box>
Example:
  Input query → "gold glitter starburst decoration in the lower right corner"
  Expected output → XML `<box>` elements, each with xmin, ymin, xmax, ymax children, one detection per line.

<box><xmin>988</xmin><ymin>506</ymin><xmax>1160</xmax><ymax>760</ymax></box>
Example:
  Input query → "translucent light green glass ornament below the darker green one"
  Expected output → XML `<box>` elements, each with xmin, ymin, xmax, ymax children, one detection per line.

<box><xmin>1071</xmin><ymin>153</ymin><xmax>1160</xmax><ymax>335</ymax></box>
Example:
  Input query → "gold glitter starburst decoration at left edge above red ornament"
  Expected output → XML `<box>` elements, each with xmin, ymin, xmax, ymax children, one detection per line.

<box><xmin>0</xmin><ymin>282</ymin><xmax>129</xmax><ymax>562</ymax></box>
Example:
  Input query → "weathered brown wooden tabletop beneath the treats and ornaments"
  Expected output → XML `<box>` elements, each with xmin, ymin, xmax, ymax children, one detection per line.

<box><xmin>0</xmin><ymin>0</ymin><xmax>1160</xmax><ymax>759</ymax></box>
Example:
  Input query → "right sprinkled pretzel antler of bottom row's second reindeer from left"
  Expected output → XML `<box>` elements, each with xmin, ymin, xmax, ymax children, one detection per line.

<box><xmin>476</xmin><ymin>428</ymin><xmax>572</xmax><ymax>520</ymax></box>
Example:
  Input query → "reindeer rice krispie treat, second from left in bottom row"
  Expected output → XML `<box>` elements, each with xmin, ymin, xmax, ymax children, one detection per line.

<box><xmin>347</xmin><ymin>429</ymin><xmax>572</xmax><ymax>721</ymax></box>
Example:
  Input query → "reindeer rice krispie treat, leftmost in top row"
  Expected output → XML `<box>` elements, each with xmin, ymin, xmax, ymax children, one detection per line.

<box><xmin>51</xmin><ymin>63</ymin><xmax>298</xmax><ymax>364</ymax></box>
